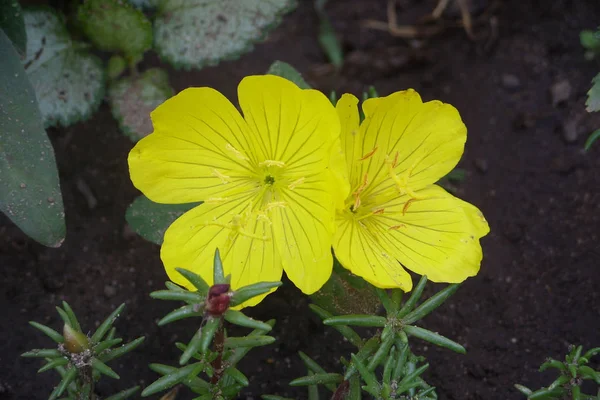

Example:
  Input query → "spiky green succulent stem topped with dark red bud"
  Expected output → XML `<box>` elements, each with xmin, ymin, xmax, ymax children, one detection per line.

<box><xmin>142</xmin><ymin>250</ymin><xmax>281</xmax><ymax>400</ymax></box>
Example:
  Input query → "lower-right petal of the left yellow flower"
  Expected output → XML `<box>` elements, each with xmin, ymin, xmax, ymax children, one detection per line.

<box><xmin>272</xmin><ymin>173</ymin><xmax>335</xmax><ymax>294</ymax></box>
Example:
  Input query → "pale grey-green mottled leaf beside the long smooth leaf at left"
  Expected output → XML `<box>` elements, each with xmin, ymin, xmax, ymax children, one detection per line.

<box><xmin>23</xmin><ymin>8</ymin><xmax>104</xmax><ymax>127</ymax></box>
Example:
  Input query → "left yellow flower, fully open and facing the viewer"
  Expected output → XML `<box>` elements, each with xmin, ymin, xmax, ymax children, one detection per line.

<box><xmin>129</xmin><ymin>75</ymin><xmax>345</xmax><ymax>305</ymax></box>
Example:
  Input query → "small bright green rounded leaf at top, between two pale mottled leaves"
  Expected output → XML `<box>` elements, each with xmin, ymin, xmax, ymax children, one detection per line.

<box><xmin>77</xmin><ymin>0</ymin><xmax>152</xmax><ymax>60</ymax></box>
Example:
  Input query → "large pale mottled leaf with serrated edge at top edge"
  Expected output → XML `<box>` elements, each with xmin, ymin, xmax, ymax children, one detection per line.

<box><xmin>154</xmin><ymin>0</ymin><xmax>295</xmax><ymax>69</ymax></box>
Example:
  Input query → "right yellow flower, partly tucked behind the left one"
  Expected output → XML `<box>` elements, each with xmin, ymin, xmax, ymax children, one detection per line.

<box><xmin>333</xmin><ymin>90</ymin><xmax>489</xmax><ymax>291</ymax></box>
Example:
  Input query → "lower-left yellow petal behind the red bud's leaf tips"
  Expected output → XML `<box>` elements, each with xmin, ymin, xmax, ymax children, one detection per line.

<box><xmin>161</xmin><ymin>191</ymin><xmax>283</xmax><ymax>306</ymax></box>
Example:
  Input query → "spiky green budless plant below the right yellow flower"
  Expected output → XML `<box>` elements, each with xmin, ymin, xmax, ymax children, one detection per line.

<box><xmin>290</xmin><ymin>277</ymin><xmax>465</xmax><ymax>400</ymax></box>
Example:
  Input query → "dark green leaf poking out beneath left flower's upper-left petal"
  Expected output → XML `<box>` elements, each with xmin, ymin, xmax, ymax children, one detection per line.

<box><xmin>125</xmin><ymin>195</ymin><xmax>202</xmax><ymax>244</ymax></box>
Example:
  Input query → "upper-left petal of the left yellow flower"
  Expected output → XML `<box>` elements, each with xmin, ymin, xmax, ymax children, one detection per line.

<box><xmin>128</xmin><ymin>88</ymin><xmax>257</xmax><ymax>203</ymax></box>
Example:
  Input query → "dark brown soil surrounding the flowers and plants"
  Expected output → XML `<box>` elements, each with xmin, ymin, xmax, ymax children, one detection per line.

<box><xmin>0</xmin><ymin>0</ymin><xmax>600</xmax><ymax>400</ymax></box>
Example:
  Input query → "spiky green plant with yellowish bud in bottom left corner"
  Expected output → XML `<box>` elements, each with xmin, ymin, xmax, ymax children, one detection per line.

<box><xmin>21</xmin><ymin>301</ymin><xmax>144</xmax><ymax>400</ymax></box>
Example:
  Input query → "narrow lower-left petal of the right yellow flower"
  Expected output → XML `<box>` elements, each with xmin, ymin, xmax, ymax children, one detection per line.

<box><xmin>333</xmin><ymin>218</ymin><xmax>412</xmax><ymax>292</ymax></box>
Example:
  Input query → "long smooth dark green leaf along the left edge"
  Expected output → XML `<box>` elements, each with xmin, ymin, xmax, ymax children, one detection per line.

<box><xmin>0</xmin><ymin>30</ymin><xmax>65</xmax><ymax>247</ymax></box>
